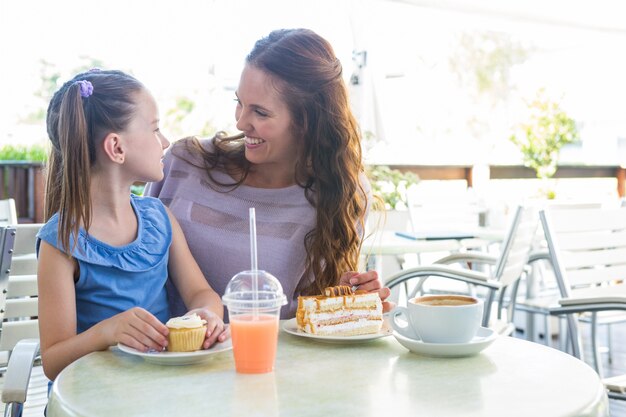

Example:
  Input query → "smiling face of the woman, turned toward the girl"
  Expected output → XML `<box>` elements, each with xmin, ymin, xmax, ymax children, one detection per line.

<box><xmin>235</xmin><ymin>65</ymin><xmax>298</xmax><ymax>177</ymax></box>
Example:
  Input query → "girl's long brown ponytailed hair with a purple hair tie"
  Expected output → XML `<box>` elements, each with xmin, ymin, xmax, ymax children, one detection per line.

<box><xmin>44</xmin><ymin>70</ymin><xmax>144</xmax><ymax>253</ymax></box>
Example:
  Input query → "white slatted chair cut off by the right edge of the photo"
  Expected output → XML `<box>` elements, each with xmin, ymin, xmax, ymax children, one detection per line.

<box><xmin>540</xmin><ymin>208</ymin><xmax>626</xmax><ymax>400</ymax></box>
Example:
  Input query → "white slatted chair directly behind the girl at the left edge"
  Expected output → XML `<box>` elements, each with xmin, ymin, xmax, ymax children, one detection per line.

<box><xmin>0</xmin><ymin>225</ymin><xmax>48</xmax><ymax>416</ymax></box>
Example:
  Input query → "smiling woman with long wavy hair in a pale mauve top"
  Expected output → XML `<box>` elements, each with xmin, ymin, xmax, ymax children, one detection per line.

<box><xmin>146</xmin><ymin>29</ymin><xmax>389</xmax><ymax>318</ymax></box>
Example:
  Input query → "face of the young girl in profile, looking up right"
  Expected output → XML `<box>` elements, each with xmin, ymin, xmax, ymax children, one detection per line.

<box><xmin>121</xmin><ymin>90</ymin><xmax>170</xmax><ymax>182</ymax></box>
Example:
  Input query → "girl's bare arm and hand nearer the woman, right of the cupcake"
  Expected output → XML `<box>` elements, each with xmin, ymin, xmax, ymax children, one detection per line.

<box><xmin>166</xmin><ymin>208</ymin><xmax>228</xmax><ymax>349</ymax></box>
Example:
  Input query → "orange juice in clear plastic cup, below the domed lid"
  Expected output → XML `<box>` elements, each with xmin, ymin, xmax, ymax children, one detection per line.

<box><xmin>230</xmin><ymin>314</ymin><xmax>278</xmax><ymax>374</ymax></box>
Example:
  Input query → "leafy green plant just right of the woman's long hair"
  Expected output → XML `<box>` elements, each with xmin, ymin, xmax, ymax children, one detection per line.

<box><xmin>367</xmin><ymin>165</ymin><xmax>419</xmax><ymax>210</ymax></box>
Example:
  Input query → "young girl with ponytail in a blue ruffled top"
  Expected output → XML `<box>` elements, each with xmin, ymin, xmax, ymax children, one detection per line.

<box><xmin>38</xmin><ymin>70</ymin><xmax>226</xmax><ymax>379</ymax></box>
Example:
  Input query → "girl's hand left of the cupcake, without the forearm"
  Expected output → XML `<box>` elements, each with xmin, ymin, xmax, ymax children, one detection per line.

<box><xmin>100</xmin><ymin>307</ymin><xmax>169</xmax><ymax>352</ymax></box>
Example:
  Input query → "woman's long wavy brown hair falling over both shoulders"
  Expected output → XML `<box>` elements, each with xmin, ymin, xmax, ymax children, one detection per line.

<box><xmin>179</xmin><ymin>29</ymin><xmax>367</xmax><ymax>294</ymax></box>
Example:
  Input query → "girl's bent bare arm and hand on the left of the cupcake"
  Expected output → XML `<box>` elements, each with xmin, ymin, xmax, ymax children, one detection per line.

<box><xmin>37</xmin><ymin>241</ymin><xmax>167</xmax><ymax>380</ymax></box>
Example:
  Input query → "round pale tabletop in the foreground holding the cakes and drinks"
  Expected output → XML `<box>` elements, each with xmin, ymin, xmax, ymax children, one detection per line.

<box><xmin>48</xmin><ymin>324</ymin><xmax>609</xmax><ymax>417</ymax></box>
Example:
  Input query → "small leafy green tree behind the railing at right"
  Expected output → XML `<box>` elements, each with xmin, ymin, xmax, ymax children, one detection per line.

<box><xmin>510</xmin><ymin>90</ymin><xmax>580</xmax><ymax>179</ymax></box>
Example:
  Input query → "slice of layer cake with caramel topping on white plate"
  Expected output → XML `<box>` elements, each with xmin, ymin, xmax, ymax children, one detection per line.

<box><xmin>296</xmin><ymin>285</ymin><xmax>383</xmax><ymax>336</ymax></box>
